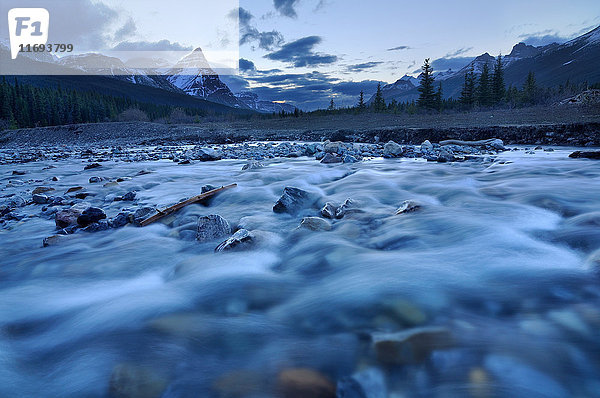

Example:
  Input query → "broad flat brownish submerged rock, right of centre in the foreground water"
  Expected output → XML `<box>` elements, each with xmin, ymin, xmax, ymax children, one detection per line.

<box><xmin>373</xmin><ymin>327</ymin><xmax>454</xmax><ymax>365</ymax></box>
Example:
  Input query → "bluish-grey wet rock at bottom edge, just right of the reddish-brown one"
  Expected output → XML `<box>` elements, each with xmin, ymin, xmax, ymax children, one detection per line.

<box><xmin>337</xmin><ymin>368</ymin><xmax>388</xmax><ymax>398</ymax></box>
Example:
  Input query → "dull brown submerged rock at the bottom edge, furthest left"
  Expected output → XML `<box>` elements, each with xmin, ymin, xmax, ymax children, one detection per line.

<box><xmin>109</xmin><ymin>363</ymin><xmax>167</xmax><ymax>398</ymax></box>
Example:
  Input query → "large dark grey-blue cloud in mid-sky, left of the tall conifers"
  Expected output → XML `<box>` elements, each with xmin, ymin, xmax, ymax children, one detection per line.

<box><xmin>265</xmin><ymin>36</ymin><xmax>338</xmax><ymax>68</ymax></box>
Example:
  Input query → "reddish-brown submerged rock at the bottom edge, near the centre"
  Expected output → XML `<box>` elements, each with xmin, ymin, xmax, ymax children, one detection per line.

<box><xmin>277</xmin><ymin>368</ymin><xmax>336</xmax><ymax>398</ymax></box>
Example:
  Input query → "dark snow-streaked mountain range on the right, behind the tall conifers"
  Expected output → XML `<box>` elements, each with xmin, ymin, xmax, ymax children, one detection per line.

<box><xmin>376</xmin><ymin>26</ymin><xmax>600</xmax><ymax>102</ymax></box>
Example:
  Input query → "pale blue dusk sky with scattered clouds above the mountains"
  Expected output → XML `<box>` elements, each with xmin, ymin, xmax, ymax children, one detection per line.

<box><xmin>0</xmin><ymin>0</ymin><xmax>600</xmax><ymax>110</ymax></box>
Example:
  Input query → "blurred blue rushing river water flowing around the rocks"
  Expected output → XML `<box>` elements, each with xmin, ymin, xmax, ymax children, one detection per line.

<box><xmin>0</xmin><ymin>149</ymin><xmax>600</xmax><ymax>397</ymax></box>
